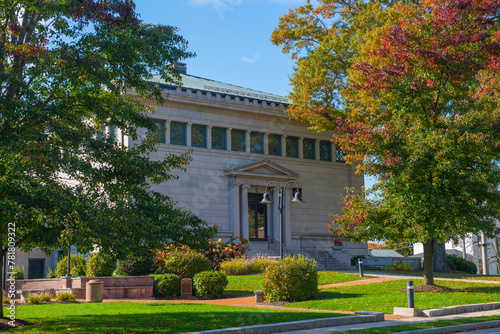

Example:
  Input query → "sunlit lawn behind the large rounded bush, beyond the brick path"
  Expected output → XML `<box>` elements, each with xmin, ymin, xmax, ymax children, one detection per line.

<box><xmin>225</xmin><ymin>271</ymin><xmax>369</xmax><ymax>297</ymax></box>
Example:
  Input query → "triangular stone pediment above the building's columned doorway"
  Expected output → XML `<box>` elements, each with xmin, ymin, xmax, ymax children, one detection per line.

<box><xmin>224</xmin><ymin>159</ymin><xmax>299</xmax><ymax>179</ymax></box>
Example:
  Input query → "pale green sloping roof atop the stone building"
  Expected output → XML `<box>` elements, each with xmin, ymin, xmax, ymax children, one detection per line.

<box><xmin>152</xmin><ymin>73</ymin><xmax>287</xmax><ymax>103</ymax></box>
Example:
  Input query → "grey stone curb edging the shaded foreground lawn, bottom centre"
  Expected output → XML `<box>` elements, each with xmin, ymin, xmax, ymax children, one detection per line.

<box><xmin>182</xmin><ymin>311</ymin><xmax>384</xmax><ymax>334</ymax></box>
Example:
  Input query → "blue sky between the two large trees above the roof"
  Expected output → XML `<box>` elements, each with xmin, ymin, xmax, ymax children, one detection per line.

<box><xmin>135</xmin><ymin>0</ymin><xmax>305</xmax><ymax>96</ymax></box>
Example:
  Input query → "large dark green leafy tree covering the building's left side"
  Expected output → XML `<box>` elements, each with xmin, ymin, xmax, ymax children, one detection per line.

<box><xmin>0</xmin><ymin>0</ymin><xmax>214</xmax><ymax>316</ymax></box>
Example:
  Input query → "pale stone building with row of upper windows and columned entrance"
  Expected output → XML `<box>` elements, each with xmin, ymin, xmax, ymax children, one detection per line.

<box><xmin>14</xmin><ymin>64</ymin><xmax>368</xmax><ymax>278</ymax></box>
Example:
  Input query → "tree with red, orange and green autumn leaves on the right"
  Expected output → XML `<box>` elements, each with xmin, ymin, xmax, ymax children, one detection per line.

<box><xmin>273</xmin><ymin>0</ymin><xmax>500</xmax><ymax>284</ymax></box>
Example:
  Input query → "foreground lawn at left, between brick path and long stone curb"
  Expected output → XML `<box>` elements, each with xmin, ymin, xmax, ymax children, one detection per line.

<box><xmin>8</xmin><ymin>302</ymin><xmax>342</xmax><ymax>334</ymax></box>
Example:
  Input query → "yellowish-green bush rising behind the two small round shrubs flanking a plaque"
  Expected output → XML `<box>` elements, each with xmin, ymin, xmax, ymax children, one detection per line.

<box><xmin>159</xmin><ymin>251</ymin><xmax>212</xmax><ymax>278</ymax></box>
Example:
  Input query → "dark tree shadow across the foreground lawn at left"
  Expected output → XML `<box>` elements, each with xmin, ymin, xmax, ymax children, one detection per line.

<box><xmin>19</xmin><ymin>303</ymin><xmax>333</xmax><ymax>334</ymax></box>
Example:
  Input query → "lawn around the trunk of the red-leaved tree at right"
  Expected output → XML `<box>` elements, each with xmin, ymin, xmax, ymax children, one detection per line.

<box><xmin>287</xmin><ymin>280</ymin><xmax>500</xmax><ymax>314</ymax></box>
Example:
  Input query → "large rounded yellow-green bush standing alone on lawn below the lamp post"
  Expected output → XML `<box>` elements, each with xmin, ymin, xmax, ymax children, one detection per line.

<box><xmin>263</xmin><ymin>255</ymin><xmax>318</xmax><ymax>302</ymax></box>
